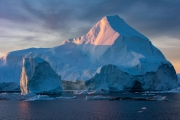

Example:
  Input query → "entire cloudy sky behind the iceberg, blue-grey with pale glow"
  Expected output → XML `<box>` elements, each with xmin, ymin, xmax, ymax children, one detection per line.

<box><xmin>0</xmin><ymin>0</ymin><xmax>180</xmax><ymax>73</ymax></box>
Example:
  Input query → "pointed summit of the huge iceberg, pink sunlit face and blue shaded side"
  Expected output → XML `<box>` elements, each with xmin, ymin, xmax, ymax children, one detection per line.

<box><xmin>72</xmin><ymin>15</ymin><xmax>149</xmax><ymax>45</ymax></box>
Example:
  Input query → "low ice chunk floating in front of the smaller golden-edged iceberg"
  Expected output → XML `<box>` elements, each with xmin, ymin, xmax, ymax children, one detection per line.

<box><xmin>24</xmin><ymin>95</ymin><xmax>54</xmax><ymax>101</ymax></box>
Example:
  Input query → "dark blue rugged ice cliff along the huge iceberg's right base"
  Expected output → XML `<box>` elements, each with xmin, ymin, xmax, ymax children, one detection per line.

<box><xmin>86</xmin><ymin>64</ymin><xmax>178</xmax><ymax>92</ymax></box>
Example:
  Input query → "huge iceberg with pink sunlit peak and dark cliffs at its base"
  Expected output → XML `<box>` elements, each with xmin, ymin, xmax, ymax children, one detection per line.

<box><xmin>0</xmin><ymin>15</ymin><xmax>179</xmax><ymax>91</ymax></box>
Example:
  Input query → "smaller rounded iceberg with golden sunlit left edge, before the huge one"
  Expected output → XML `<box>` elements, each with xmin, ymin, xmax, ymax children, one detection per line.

<box><xmin>20</xmin><ymin>57</ymin><xmax>62</xmax><ymax>95</ymax></box>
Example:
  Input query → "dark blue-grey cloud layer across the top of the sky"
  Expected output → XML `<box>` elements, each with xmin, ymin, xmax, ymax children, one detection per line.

<box><xmin>0</xmin><ymin>0</ymin><xmax>180</xmax><ymax>39</ymax></box>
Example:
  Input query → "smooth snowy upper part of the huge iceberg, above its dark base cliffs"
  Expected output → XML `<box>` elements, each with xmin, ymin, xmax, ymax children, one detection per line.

<box><xmin>0</xmin><ymin>15</ymin><xmax>178</xmax><ymax>90</ymax></box>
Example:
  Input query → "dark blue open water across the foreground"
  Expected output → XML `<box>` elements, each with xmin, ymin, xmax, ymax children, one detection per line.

<box><xmin>0</xmin><ymin>93</ymin><xmax>180</xmax><ymax>120</ymax></box>
